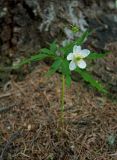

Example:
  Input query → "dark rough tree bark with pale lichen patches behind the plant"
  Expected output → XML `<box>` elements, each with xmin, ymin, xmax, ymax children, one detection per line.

<box><xmin>0</xmin><ymin>0</ymin><xmax>117</xmax><ymax>95</ymax></box>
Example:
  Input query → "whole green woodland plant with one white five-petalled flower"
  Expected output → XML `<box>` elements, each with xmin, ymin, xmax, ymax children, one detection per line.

<box><xmin>13</xmin><ymin>26</ymin><xmax>108</xmax><ymax>129</ymax></box>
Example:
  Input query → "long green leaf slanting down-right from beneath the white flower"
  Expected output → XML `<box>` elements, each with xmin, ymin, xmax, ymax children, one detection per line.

<box><xmin>75</xmin><ymin>68</ymin><xmax>108</xmax><ymax>94</ymax></box>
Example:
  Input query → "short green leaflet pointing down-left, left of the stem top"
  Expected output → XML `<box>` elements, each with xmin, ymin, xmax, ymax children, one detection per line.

<box><xmin>46</xmin><ymin>58</ymin><xmax>62</xmax><ymax>77</ymax></box>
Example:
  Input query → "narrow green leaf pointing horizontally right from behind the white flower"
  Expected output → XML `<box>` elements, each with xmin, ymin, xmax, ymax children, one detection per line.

<box><xmin>87</xmin><ymin>51</ymin><xmax>110</xmax><ymax>59</ymax></box>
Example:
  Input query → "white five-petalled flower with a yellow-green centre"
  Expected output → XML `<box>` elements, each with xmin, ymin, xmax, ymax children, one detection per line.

<box><xmin>67</xmin><ymin>45</ymin><xmax>90</xmax><ymax>71</ymax></box>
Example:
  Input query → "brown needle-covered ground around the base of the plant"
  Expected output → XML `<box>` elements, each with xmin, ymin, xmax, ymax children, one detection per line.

<box><xmin>0</xmin><ymin>59</ymin><xmax>117</xmax><ymax>160</ymax></box>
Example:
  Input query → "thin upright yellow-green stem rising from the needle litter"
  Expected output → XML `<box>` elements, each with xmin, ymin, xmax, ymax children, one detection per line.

<box><xmin>61</xmin><ymin>75</ymin><xmax>65</xmax><ymax>126</ymax></box>
